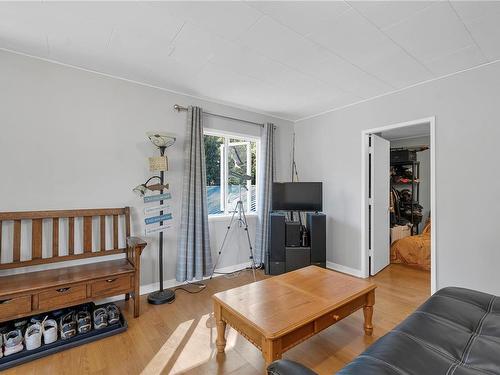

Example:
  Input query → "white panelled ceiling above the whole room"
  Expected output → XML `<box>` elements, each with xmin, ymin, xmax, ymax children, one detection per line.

<box><xmin>0</xmin><ymin>1</ymin><xmax>500</xmax><ymax>120</ymax></box>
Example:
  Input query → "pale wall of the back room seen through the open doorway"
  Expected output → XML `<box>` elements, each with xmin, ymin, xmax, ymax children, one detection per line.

<box><xmin>391</xmin><ymin>137</ymin><xmax>431</xmax><ymax>228</ymax></box>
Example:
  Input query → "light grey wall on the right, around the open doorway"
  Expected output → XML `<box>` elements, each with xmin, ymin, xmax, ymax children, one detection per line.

<box><xmin>295</xmin><ymin>63</ymin><xmax>500</xmax><ymax>294</ymax></box>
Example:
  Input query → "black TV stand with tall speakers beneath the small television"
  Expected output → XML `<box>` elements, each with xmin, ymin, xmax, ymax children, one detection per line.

<box><xmin>265</xmin><ymin>211</ymin><xmax>326</xmax><ymax>275</ymax></box>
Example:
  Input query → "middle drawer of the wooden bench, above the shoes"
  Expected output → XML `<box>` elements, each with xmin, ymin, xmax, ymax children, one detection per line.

<box><xmin>38</xmin><ymin>284</ymin><xmax>87</xmax><ymax>310</ymax></box>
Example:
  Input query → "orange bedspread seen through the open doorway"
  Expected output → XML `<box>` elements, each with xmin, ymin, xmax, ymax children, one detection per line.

<box><xmin>391</xmin><ymin>222</ymin><xmax>431</xmax><ymax>271</ymax></box>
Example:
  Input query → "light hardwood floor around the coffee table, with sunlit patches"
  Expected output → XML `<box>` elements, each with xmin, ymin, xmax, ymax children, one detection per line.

<box><xmin>4</xmin><ymin>264</ymin><xmax>430</xmax><ymax>375</ymax></box>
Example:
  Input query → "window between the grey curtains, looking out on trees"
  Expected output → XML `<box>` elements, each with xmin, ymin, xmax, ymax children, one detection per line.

<box><xmin>204</xmin><ymin>131</ymin><xmax>258</xmax><ymax>215</ymax></box>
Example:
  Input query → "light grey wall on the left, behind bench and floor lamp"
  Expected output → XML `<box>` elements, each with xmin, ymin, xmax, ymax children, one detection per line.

<box><xmin>0</xmin><ymin>51</ymin><xmax>293</xmax><ymax>285</ymax></box>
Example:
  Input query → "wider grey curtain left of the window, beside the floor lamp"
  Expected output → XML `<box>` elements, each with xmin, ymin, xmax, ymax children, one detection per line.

<box><xmin>175</xmin><ymin>106</ymin><xmax>212</xmax><ymax>281</ymax></box>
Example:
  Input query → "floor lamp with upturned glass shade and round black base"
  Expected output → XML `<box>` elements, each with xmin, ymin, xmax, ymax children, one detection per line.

<box><xmin>134</xmin><ymin>132</ymin><xmax>175</xmax><ymax>305</ymax></box>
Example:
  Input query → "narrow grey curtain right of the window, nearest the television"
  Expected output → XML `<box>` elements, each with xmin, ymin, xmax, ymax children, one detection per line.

<box><xmin>254</xmin><ymin>123</ymin><xmax>275</xmax><ymax>265</ymax></box>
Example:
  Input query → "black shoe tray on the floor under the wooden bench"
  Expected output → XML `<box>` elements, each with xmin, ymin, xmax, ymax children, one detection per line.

<box><xmin>0</xmin><ymin>304</ymin><xmax>128</xmax><ymax>371</ymax></box>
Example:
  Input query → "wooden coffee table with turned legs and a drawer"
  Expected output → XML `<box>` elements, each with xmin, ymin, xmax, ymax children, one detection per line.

<box><xmin>213</xmin><ymin>266</ymin><xmax>376</xmax><ymax>365</ymax></box>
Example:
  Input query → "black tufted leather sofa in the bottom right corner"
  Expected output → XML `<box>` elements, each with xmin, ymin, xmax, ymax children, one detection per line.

<box><xmin>267</xmin><ymin>288</ymin><xmax>500</xmax><ymax>375</ymax></box>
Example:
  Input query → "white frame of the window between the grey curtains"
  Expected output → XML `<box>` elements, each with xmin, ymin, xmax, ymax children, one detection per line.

<box><xmin>203</xmin><ymin>129</ymin><xmax>260</xmax><ymax>219</ymax></box>
